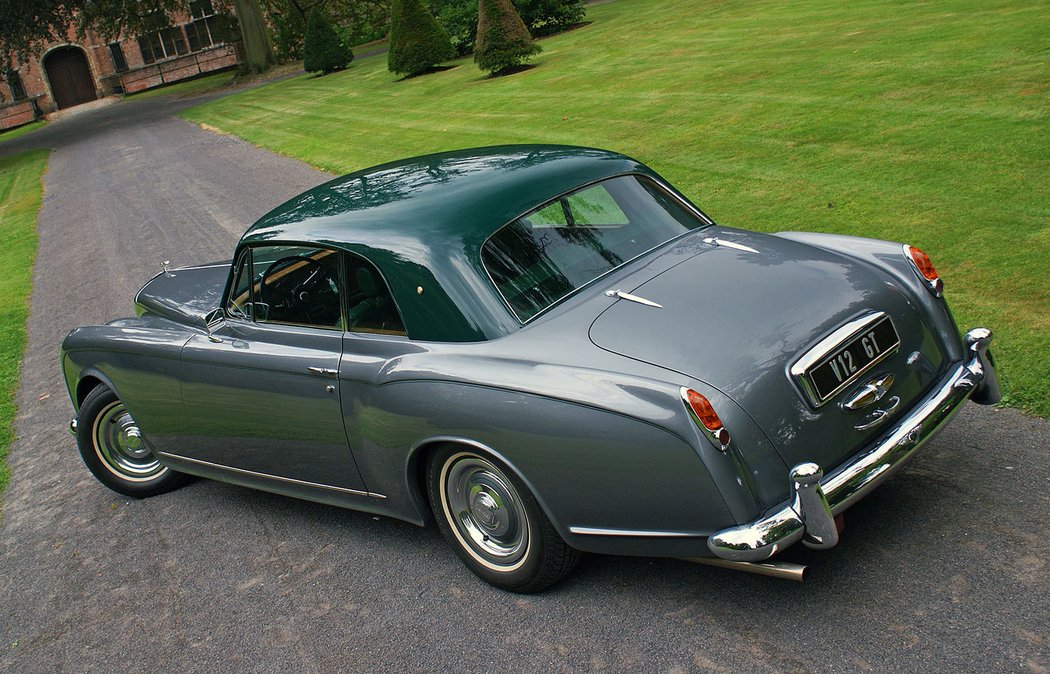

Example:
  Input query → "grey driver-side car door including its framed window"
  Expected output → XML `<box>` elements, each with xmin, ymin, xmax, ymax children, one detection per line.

<box><xmin>174</xmin><ymin>246</ymin><xmax>366</xmax><ymax>491</ymax></box>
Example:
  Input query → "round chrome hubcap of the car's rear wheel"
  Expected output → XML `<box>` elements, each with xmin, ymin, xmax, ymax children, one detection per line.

<box><xmin>443</xmin><ymin>455</ymin><xmax>528</xmax><ymax>571</ymax></box>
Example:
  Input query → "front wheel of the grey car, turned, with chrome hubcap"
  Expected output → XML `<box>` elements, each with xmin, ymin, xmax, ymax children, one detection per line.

<box><xmin>77</xmin><ymin>384</ymin><xmax>189</xmax><ymax>498</ymax></box>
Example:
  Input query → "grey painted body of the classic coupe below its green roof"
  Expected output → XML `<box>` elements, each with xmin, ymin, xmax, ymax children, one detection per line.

<box><xmin>62</xmin><ymin>148</ymin><xmax>965</xmax><ymax>556</ymax></box>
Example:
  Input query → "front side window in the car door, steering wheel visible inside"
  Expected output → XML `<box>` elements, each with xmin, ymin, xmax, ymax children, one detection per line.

<box><xmin>247</xmin><ymin>246</ymin><xmax>342</xmax><ymax>330</ymax></box>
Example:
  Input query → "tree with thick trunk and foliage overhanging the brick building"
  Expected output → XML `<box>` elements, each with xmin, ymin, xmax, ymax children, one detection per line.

<box><xmin>0</xmin><ymin>0</ymin><xmax>274</xmax><ymax>70</ymax></box>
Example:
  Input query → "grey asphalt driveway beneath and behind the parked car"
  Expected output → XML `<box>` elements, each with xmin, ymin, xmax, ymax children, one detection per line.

<box><xmin>0</xmin><ymin>91</ymin><xmax>1050</xmax><ymax>672</ymax></box>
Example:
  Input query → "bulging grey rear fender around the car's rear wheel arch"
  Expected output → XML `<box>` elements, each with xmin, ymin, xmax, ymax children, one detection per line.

<box><xmin>351</xmin><ymin>380</ymin><xmax>735</xmax><ymax>547</ymax></box>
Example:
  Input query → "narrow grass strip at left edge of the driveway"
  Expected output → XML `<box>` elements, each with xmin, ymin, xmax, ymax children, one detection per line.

<box><xmin>0</xmin><ymin>150</ymin><xmax>47</xmax><ymax>493</ymax></box>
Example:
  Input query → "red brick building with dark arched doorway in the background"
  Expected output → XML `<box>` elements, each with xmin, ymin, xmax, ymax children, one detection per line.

<box><xmin>0</xmin><ymin>0</ymin><xmax>239</xmax><ymax>130</ymax></box>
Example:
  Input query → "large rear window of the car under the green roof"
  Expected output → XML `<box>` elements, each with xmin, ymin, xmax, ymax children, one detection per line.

<box><xmin>481</xmin><ymin>175</ymin><xmax>708</xmax><ymax>321</ymax></box>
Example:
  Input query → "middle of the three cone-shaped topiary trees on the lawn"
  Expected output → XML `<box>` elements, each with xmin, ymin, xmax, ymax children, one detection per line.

<box><xmin>386</xmin><ymin>0</ymin><xmax>456</xmax><ymax>76</ymax></box>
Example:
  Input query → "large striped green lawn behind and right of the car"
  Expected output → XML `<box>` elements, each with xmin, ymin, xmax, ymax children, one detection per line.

<box><xmin>183</xmin><ymin>0</ymin><xmax>1050</xmax><ymax>416</ymax></box>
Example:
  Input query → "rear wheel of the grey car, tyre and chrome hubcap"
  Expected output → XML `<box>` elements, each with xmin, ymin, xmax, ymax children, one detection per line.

<box><xmin>427</xmin><ymin>447</ymin><xmax>581</xmax><ymax>593</ymax></box>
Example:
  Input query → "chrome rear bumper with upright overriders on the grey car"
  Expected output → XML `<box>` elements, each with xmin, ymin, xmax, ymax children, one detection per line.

<box><xmin>708</xmin><ymin>328</ymin><xmax>1000</xmax><ymax>562</ymax></box>
